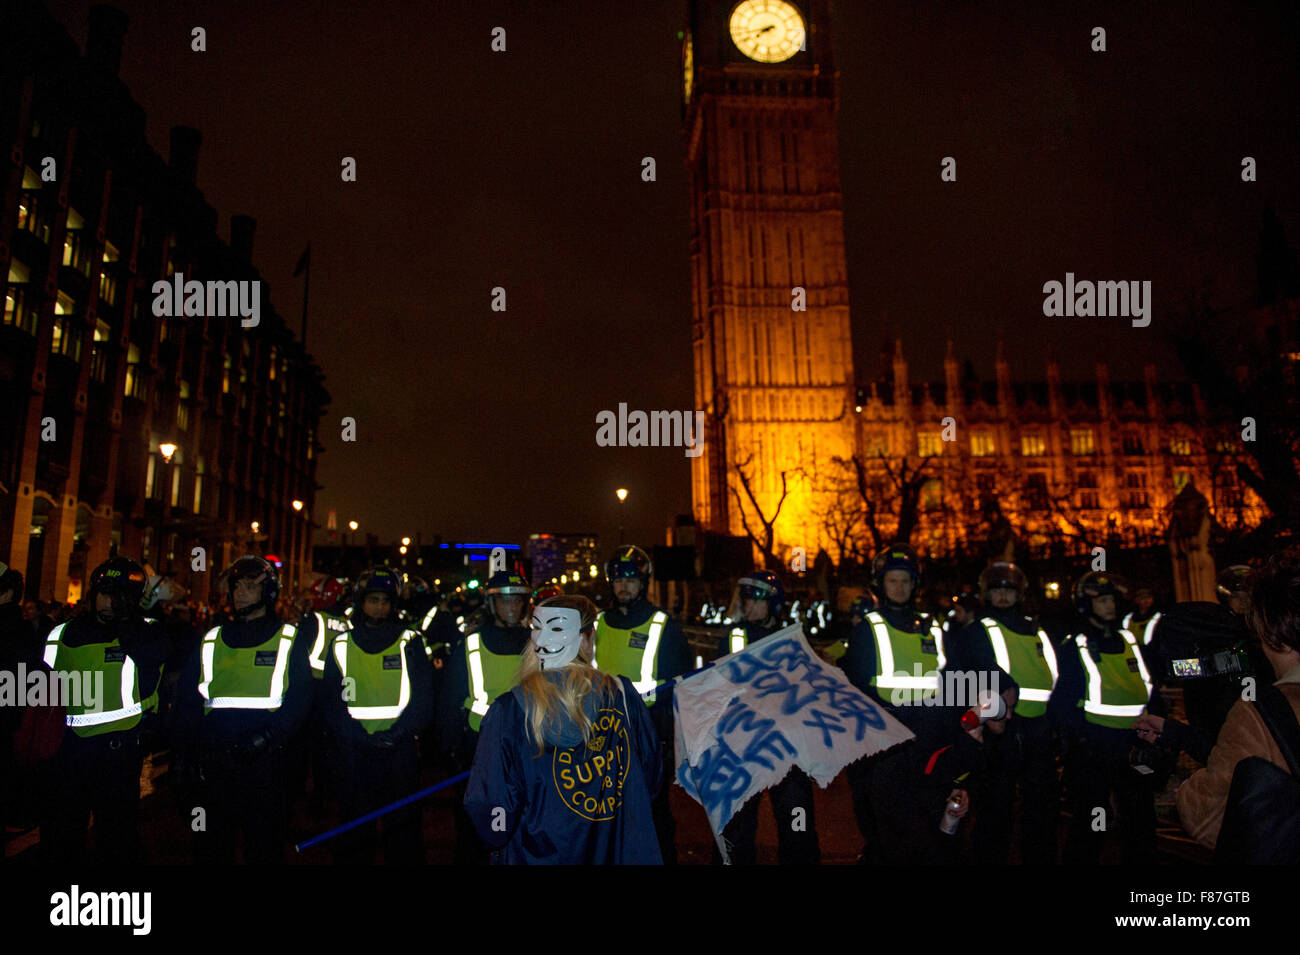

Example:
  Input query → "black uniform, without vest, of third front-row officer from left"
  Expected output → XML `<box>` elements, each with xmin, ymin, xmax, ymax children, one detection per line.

<box><xmin>321</xmin><ymin>611</ymin><xmax>433</xmax><ymax>865</ymax></box>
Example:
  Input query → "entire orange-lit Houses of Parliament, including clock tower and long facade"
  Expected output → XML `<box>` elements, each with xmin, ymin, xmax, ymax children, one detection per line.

<box><xmin>683</xmin><ymin>0</ymin><xmax>1265</xmax><ymax>564</ymax></box>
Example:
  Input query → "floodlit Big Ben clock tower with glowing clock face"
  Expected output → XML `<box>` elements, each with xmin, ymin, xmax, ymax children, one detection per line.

<box><xmin>683</xmin><ymin>0</ymin><xmax>854</xmax><ymax>565</ymax></box>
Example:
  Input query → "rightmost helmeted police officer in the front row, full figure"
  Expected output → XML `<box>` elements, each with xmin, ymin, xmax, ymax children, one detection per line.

<box><xmin>1050</xmin><ymin>570</ymin><xmax>1162</xmax><ymax>864</ymax></box>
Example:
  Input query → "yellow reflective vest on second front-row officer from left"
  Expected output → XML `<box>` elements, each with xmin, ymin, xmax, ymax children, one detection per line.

<box><xmin>199</xmin><ymin>624</ymin><xmax>298</xmax><ymax>713</ymax></box>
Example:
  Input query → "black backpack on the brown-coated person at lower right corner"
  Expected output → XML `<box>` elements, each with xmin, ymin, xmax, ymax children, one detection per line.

<box><xmin>1214</xmin><ymin>683</ymin><xmax>1300</xmax><ymax>865</ymax></box>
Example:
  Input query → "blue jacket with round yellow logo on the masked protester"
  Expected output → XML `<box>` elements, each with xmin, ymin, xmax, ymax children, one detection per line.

<box><xmin>465</xmin><ymin>677</ymin><xmax>663</xmax><ymax>865</ymax></box>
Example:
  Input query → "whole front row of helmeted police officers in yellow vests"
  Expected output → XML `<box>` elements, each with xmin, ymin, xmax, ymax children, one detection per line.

<box><xmin>30</xmin><ymin>537</ymin><xmax>1185</xmax><ymax>864</ymax></box>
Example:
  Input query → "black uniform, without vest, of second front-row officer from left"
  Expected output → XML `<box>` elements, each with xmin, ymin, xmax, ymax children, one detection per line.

<box><xmin>176</xmin><ymin>613</ymin><xmax>316</xmax><ymax>864</ymax></box>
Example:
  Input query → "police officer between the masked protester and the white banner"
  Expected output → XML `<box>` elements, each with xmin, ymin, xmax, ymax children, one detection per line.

<box><xmin>594</xmin><ymin>546</ymin><xmax>690</xmax><ymax>865</ymax></box>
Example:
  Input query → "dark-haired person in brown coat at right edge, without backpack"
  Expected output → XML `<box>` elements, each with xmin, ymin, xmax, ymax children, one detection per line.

<box><xmin>1178</xmin><ymin>559</ymin><xmax>1300</xmax><ymax>848</ymax></box>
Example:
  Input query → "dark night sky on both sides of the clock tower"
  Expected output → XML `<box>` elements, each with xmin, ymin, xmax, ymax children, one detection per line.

<box><xmin>40</xmin><ymin>0</ymin><xmax>1300</xmax><ymax>553</ymax></box>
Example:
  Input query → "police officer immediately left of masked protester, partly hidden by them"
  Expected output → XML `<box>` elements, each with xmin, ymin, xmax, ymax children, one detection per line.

<box><xmin>438</xmin><ymin>570</ymin><xmax>533</xmax><ymax>865</ymax></box>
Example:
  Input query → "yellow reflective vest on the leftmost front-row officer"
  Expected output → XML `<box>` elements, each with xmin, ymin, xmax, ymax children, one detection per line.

<box><xmin>44</xmin><ymin>624</ymin><xmax>159</xmax><ymax>737</ymax></box>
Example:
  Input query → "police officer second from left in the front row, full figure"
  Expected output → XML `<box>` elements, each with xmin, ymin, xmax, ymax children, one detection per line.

<box><xmin>176</xmin><ymin>555</ymin><xmax>317</xmax><ymax>864</ymax></box>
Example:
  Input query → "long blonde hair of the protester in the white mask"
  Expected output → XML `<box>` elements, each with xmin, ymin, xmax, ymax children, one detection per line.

<box><xmin>519</xmin><ymin>594</ymin><xmax>619</xmax><ymax>756</ymax></box>
